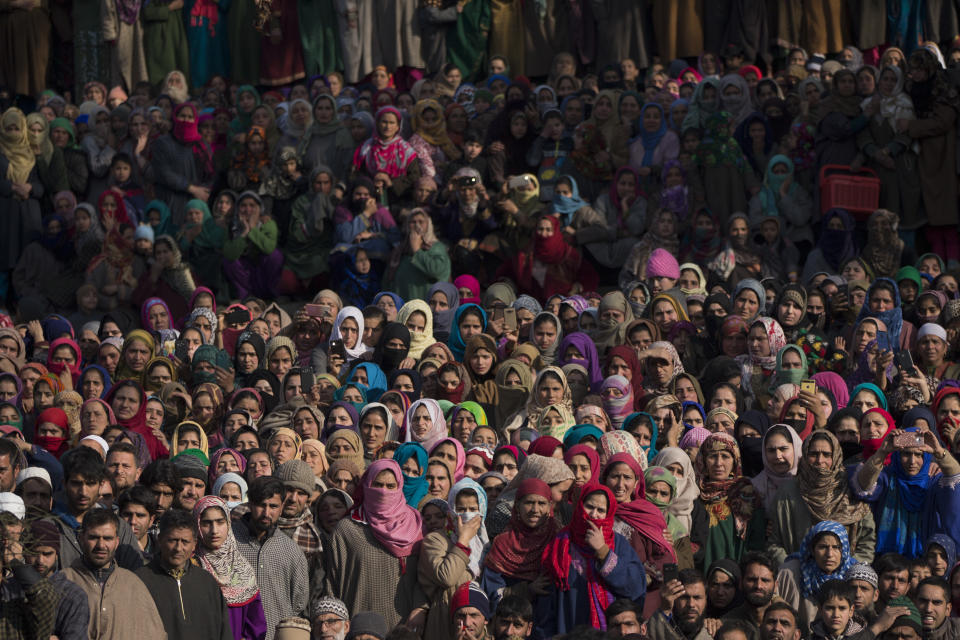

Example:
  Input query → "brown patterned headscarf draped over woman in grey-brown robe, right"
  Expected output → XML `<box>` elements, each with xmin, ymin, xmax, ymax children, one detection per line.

<box><xmin>797</xmin><ymin>430</ymin><xmax>870</xmax><ymax>526</ymax></box>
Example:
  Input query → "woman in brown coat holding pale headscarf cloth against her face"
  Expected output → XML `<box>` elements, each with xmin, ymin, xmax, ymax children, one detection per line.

<box><xmin>417</xmin><ymin>478</ymin><xmax>489</xmax><ymax>640</ymax></box>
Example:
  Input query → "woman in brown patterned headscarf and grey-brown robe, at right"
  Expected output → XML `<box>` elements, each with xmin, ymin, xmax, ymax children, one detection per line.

<box><xmin>767</xmin><ymin>430</ymin><xmax>876</xmax><ymax>563</ymax></box>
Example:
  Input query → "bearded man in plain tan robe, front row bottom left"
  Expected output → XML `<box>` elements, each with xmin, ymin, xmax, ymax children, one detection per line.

<box><xmin>61</xmin><ymin>509</ymin><xmax>166</xmax><ymax>640</ymax></box>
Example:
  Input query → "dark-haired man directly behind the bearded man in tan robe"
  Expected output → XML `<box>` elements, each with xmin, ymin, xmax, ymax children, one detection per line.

<box><xmin>53</xmin><ymin>447</ymin><xmax>143</xmax><ymax>571</ymax></box>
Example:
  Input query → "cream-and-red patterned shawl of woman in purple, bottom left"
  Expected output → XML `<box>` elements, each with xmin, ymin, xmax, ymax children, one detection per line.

<box><xmin>193</xmin><ymin>496</ymin><xmax>260</xmax><ymax>607</ymax></box>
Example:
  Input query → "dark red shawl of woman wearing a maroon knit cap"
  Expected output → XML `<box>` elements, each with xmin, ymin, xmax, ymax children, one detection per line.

<box><xmin>483</xmin><ymin>477</ymin><xmax>558</xmax><ymax>581</ymax></box>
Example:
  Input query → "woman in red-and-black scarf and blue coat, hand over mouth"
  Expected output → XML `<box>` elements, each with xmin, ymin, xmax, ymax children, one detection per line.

<box><xmin>542</xmin><ymin>485</ymin><xmax>644</xmax><ymax>636</ymax></box>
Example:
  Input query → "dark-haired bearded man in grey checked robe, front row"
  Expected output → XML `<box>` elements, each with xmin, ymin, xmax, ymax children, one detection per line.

<box><xmin>233</xmin><ymin>476</ymin><xmax>309</xmax><ymax>640</ymax></box>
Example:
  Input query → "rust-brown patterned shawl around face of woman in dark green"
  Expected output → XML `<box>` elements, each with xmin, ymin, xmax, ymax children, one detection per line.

<box><xmin>695</xmin><ymin>432</ymin><xmax>760</xmax><ymax>538</ymax></box>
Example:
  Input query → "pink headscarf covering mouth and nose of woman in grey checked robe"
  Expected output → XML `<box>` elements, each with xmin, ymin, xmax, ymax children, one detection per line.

<box><xmin>350</xmin><ymin>459</ymin><xmax>423</xmax><ymax>559</ymax></box>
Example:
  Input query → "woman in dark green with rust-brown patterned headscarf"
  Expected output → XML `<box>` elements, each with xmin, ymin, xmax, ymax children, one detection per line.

<box><xmin>690</xmin><ymin>432</ymin><xmax>766</xmax><ymax>567</ymax></box>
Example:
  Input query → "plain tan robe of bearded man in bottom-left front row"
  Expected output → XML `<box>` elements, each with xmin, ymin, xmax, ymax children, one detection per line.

<box><xmin>63</xmin><ymin>559</ymin><xmax>167</xmax><ymax>640</ymax></box>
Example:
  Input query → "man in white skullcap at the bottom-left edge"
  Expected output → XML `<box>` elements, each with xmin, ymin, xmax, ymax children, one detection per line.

<box><xmin>0</xmin><ymin>493</ymin><xmax>57</xmax><ymax>640</ymax></box>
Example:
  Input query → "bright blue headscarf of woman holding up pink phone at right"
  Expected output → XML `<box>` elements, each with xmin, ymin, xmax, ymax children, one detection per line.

<box><xmin>874</xmin><ymin>428</ymin><xmax>940</xmax><ymax>558</ymax></box>
